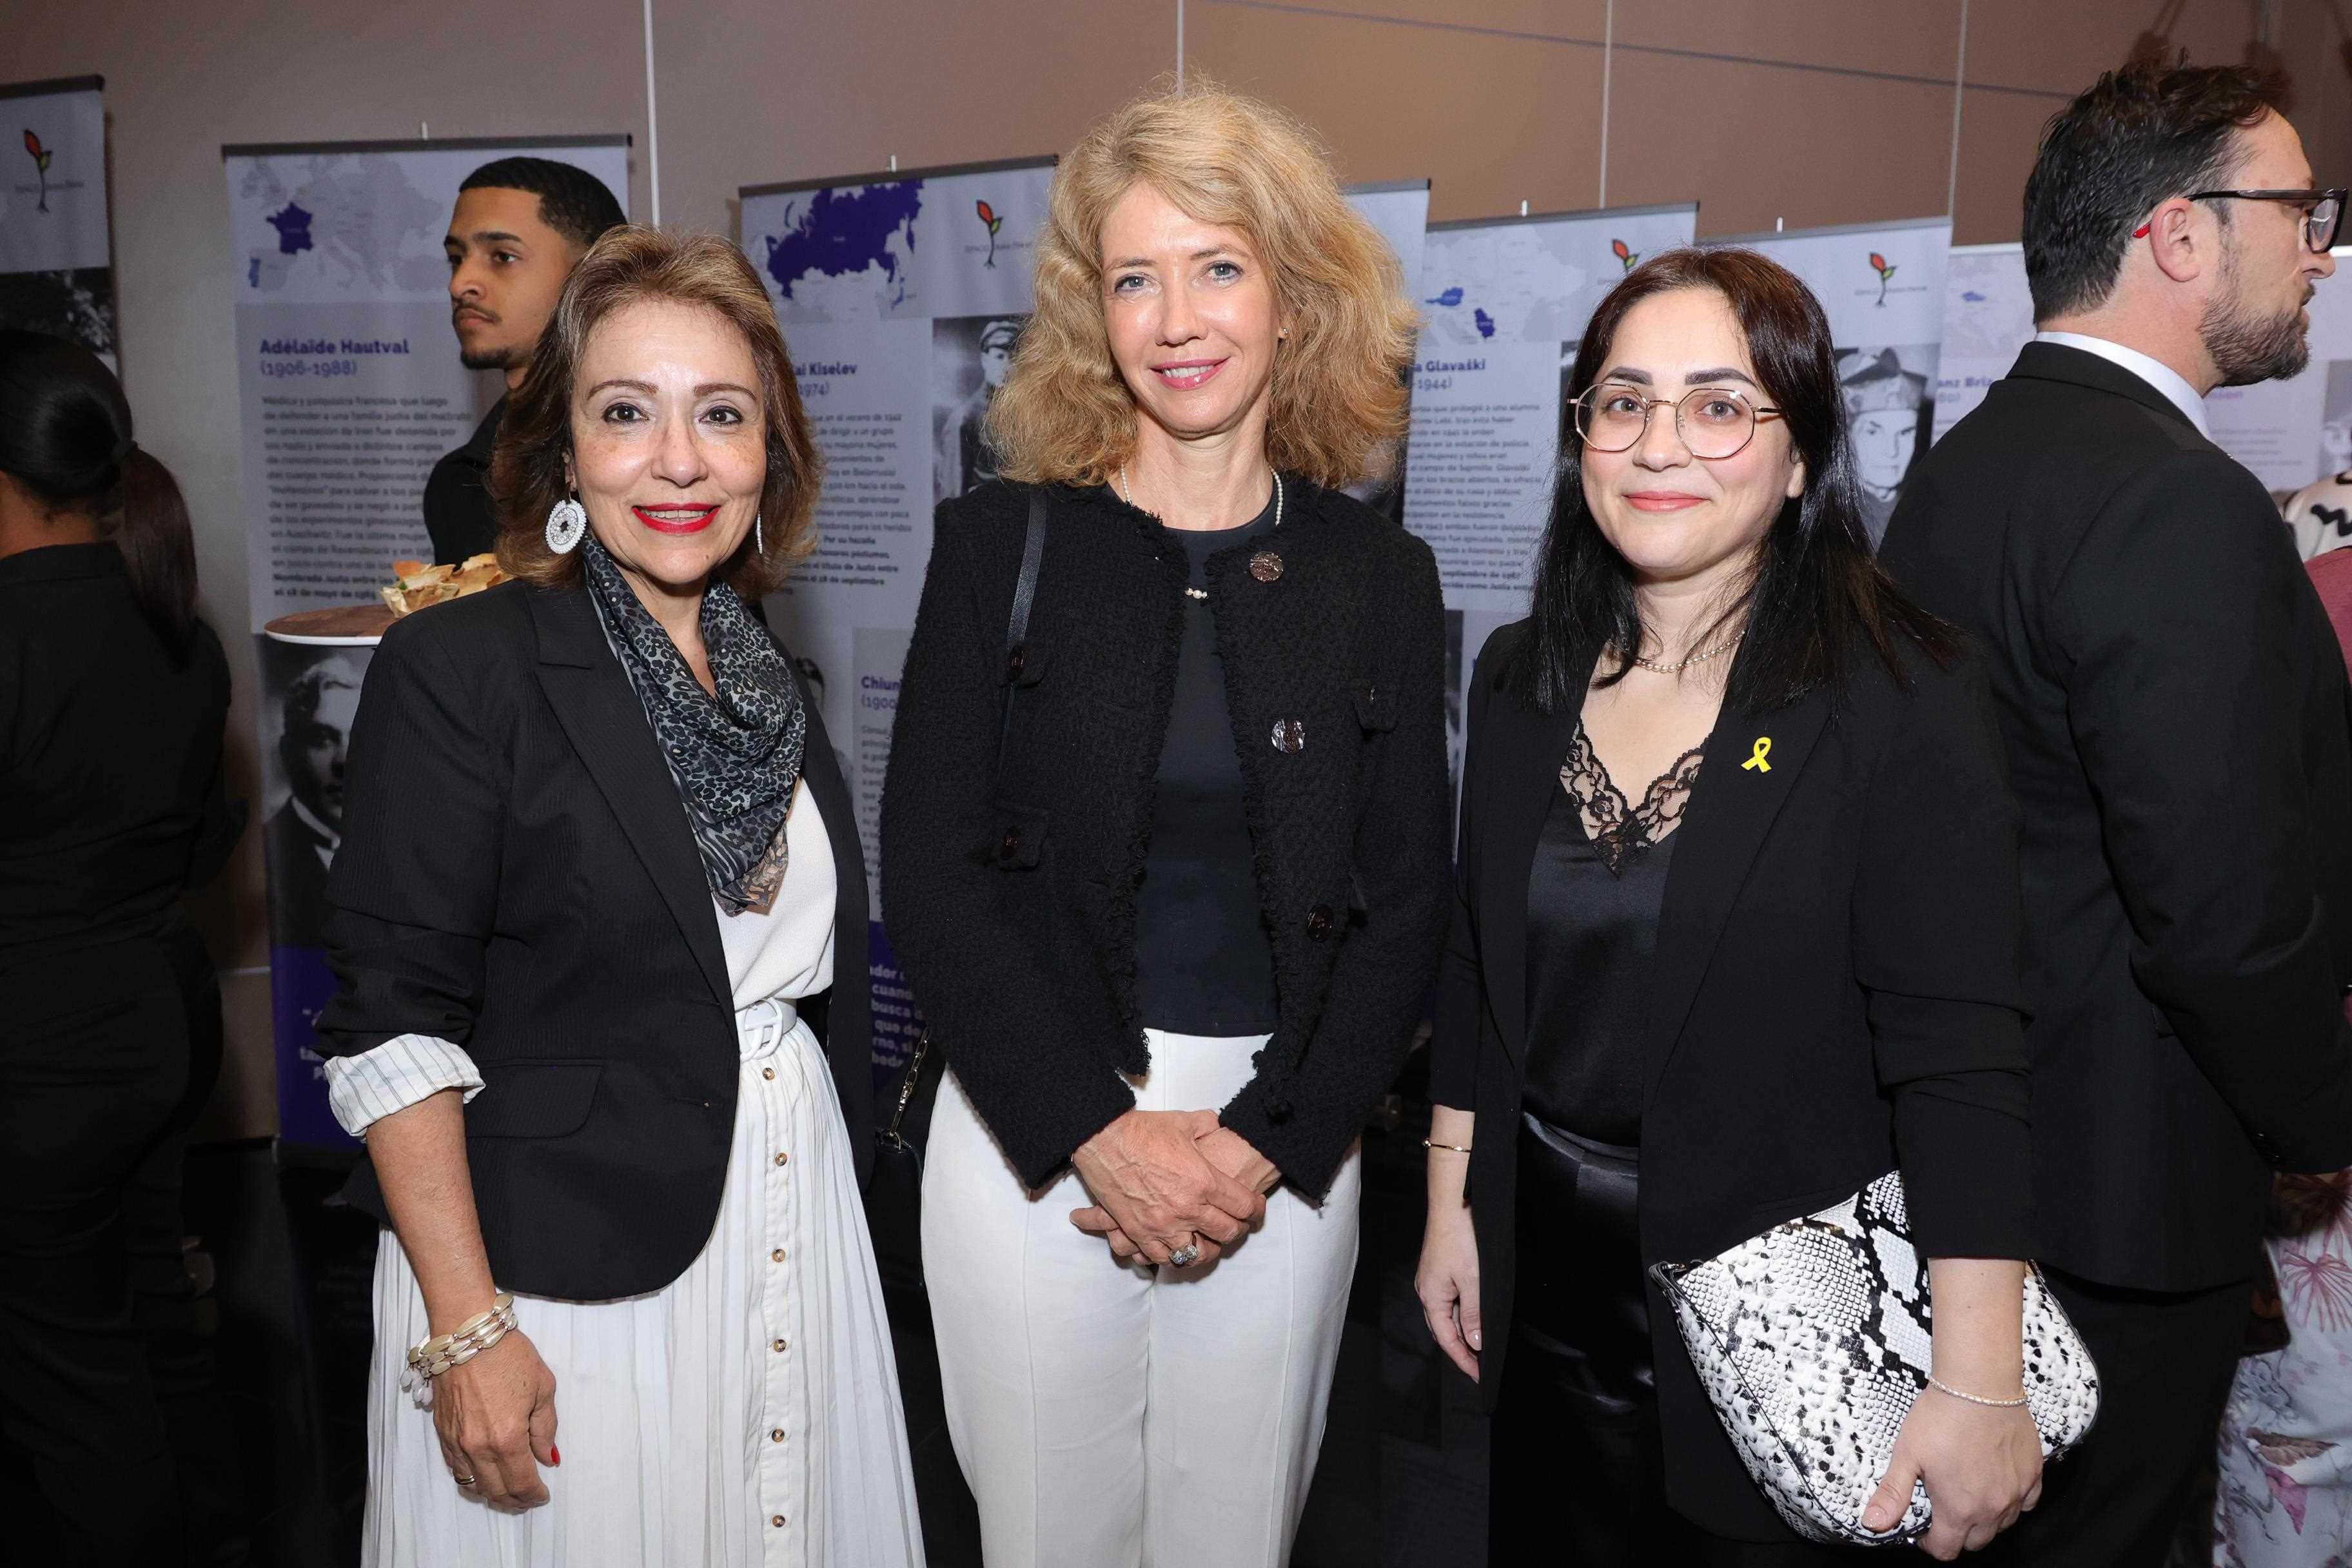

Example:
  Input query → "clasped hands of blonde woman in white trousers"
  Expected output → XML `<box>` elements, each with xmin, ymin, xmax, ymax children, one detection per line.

<box><xmin>1070</xmin><ymin>1110</ymin><xmax>1282</xmax><ymax>1267</ymax></box>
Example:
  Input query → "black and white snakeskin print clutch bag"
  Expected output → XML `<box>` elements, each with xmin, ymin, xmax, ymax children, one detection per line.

<box><xmin>1649</xmin><ymin>1171</ymin><xmax>2098</xmax><ymax>1545</ymax></box>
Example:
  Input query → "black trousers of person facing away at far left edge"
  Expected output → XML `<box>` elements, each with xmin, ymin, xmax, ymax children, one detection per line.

<box><xmin>0</xmin><ymin>931</ymin><xmax>242</xmax><ymax>1568</ymax></box>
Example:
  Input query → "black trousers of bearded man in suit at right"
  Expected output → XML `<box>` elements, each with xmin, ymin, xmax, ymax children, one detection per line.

<box><xmin>1988</xmin><ymin>1265</ymin><xmax>2253</xmax><ymax>1568</ymax></box>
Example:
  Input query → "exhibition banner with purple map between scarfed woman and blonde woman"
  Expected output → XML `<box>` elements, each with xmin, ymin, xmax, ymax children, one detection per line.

<box><xmin>741</xmin><ymin>157</ymin><xmax>1054</xmax><ymax>1088</ymax></box>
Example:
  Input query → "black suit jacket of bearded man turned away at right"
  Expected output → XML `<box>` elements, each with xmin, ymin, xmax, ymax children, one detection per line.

<box><xmin>1886</xmin><ymin>343</ymin><xmax>2352</xmax><ymax>1291</ymax></box>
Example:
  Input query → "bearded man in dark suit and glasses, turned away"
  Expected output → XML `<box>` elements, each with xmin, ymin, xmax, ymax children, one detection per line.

<box><xmin>1884</xmin><ymin>63</ymin><xmax>2352</xmax><ymax>1568</ymax></box>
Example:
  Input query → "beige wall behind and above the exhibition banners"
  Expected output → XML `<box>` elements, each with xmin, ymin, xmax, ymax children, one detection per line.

<box><xmin>0</xmin><ymin>0</ymin><xmax>2352</xmax><ymax>1131</ymax></box>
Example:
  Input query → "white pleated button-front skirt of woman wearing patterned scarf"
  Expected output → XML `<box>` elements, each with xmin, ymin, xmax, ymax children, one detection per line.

<box><xmin>362</xmin><ymin>1001</ymin><xmax>922</xmax><ymax>1568</ymax></box>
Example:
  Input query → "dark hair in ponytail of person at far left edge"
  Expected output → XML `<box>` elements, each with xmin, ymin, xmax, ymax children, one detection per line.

<box><xmin>0</xmin><ymin>331</ymin><xmax>195</xmax><ymax>663</ymax></box>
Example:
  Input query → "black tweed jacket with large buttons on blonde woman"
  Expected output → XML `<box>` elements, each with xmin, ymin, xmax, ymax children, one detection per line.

<box><xmin>882</xmin><ymin>477</ymin><xmax>1449</xmax><ymax>1194</ymax></box>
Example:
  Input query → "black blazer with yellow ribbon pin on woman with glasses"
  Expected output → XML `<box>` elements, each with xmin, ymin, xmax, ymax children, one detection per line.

<box><xmin>1430</xmin><ymin>621</ymin><xmax>2030</xmax><ymax>1540</ymax></box>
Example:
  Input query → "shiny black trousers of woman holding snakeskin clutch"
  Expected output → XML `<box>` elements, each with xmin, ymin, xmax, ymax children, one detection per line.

<box><xmin>1487</xmin><ymin>1119</ymin><xmax>1861</xmax><ymax>1568</ymax></box>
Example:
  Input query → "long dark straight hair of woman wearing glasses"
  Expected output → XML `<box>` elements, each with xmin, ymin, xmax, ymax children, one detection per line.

<box><xmin>1498</xmin><ymin>249</ymin><xmax>1959</xmax><ymax>712</ymax></box>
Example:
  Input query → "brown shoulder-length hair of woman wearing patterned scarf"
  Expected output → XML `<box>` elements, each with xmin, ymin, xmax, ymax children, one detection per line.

<box><xmin>489</xmin><ymin>226</ymin><xmax>823</xmax><ymax>587</ymax></box>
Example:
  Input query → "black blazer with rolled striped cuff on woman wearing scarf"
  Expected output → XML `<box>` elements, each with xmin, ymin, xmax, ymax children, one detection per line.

<box><xmin>317</xmin><ymin>583</ymin><xmax>872</xmax><ymax>1300</ymax></box>
